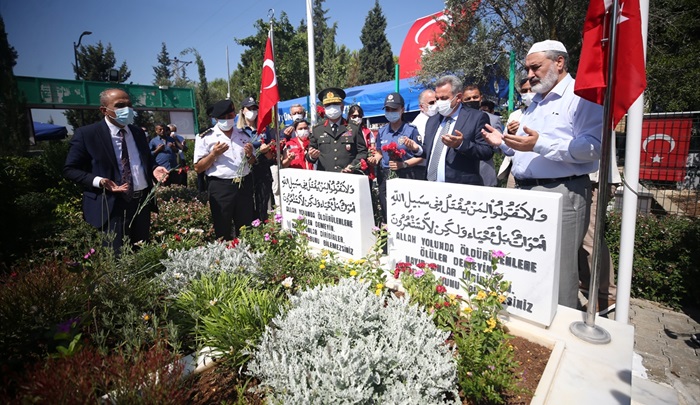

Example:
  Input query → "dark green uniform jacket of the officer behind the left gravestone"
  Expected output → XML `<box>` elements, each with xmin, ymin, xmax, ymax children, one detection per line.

<box><xmin>309</xmin><ymin>120</ymin><xmax>367</xmax><ymax>172</ymax></box>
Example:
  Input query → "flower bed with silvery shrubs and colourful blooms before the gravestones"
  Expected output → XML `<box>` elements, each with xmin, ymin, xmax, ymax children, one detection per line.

<box><xmin>0</xmin><ymin>205</ymin><xmax>556</xmax><ymax>403</ymax></box>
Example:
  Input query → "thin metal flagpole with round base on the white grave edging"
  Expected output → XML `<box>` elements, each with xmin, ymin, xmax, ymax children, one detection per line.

<box><xmin>569</xmin><ymin>0</ymin><xmax>620</xmax><ymax>344</ymax></box>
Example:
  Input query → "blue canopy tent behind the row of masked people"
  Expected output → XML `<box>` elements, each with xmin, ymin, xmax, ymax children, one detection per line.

<box><xmin>279</xmin><ymin>78</ymin><xmax>424</xmax><ymax>125</ymax></box>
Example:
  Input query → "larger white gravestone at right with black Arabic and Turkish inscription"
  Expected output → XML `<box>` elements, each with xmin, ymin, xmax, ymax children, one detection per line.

<box><xmin>387</xmin><ymin>179</ymin><xmax>562</xmax><ymax>326</ymax></box>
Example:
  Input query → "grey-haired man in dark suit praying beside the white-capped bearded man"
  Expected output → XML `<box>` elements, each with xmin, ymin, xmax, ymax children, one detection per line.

<box><xmin>423</xmin><ymin>75</ymin><xmax>493</xmax><ymax>186</ymax></box>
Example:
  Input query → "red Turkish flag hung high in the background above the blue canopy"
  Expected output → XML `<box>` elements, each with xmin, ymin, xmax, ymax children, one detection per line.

<box><xmin>399</xmin><ymin>11</ymin><xmax>447</xmax><ymax>79</ymax></box>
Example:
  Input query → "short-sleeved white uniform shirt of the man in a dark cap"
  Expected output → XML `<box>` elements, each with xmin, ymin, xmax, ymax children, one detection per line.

<box><xmin>194</xmin><ymin>126</ymin><xmax>250</xmax><ymax>180</ymax></box>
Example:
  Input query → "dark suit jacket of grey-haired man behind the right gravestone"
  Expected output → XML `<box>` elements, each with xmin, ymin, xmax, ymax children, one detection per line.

<box><xmin>423</xmin><ymin>107</ymin><xmax>493</xmax><ymax>186</ymax></box>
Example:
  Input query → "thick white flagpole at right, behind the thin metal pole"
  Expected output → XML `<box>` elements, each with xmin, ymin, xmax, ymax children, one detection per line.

<box><xmin>615</xmin><ymin>0</ymin><xmax>649</xmax><ymax>324</ymax></box>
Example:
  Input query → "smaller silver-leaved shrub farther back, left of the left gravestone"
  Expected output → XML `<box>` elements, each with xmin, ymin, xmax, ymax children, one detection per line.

<box><xmin>158</xmin><ymin>240</ymin><xmax>262</xmax><ymax>297</ymax></box>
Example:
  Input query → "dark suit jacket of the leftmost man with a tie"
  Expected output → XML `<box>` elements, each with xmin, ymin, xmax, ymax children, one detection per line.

<box><xmin>63</xmin><ymin>120</ymin><xmax>155</xmax><ymax>228</ymax></box>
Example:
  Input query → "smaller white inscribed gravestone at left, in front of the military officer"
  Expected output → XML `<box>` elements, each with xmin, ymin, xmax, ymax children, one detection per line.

<box><xmin>280</xmin><ymin>169</ymin><xmax>374</xmax><ymax>259</ymax></box>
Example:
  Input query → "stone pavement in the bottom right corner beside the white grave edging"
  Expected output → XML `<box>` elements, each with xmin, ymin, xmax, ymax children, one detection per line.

<box><xmin>629</xmin><ymin>298</ymin><xmax>700</xmax><ymax>405</ymax></box>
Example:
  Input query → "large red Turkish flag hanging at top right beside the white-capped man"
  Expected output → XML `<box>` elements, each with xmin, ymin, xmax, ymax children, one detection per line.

<box><xmin>574</xmin><ymin>0</ymin><xmax>647</xmax><ymax>126</ymax></box>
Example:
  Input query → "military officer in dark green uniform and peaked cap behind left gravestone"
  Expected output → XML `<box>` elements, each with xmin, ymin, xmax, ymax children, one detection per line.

<box><xmin>306</xmin><ymin>87</ymin><xmax>367</xmax><ymax>173</ymax></box>
